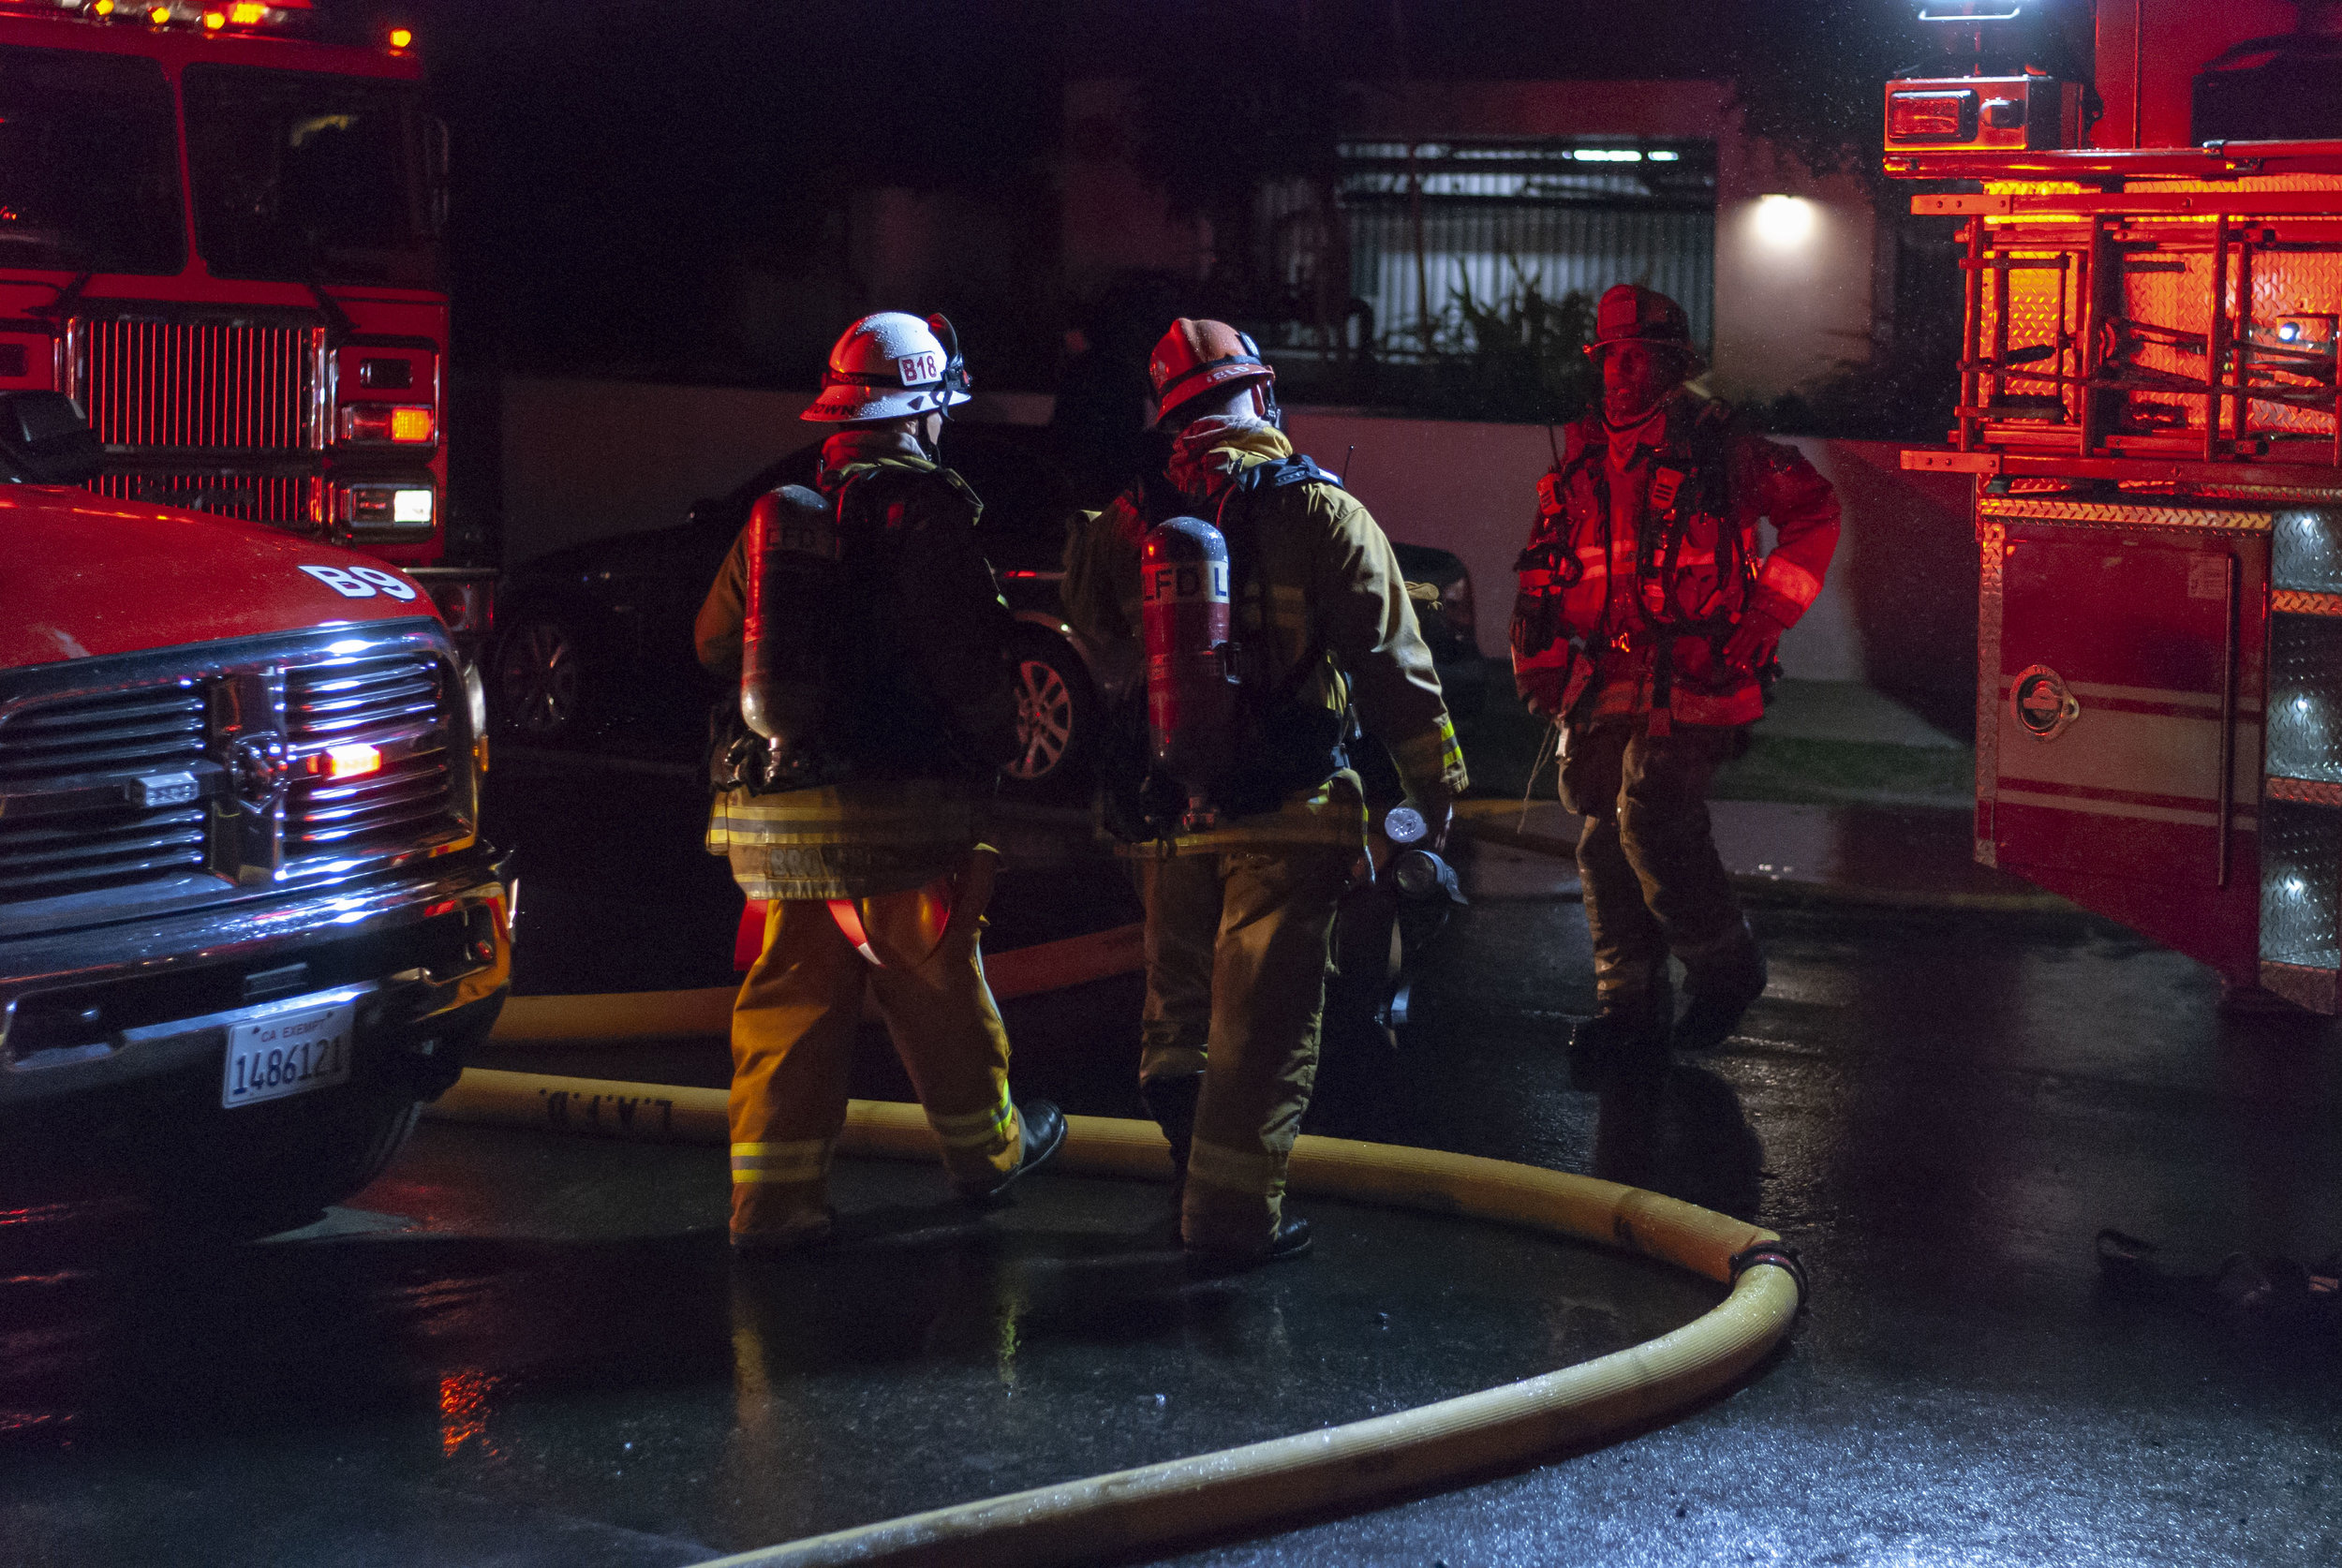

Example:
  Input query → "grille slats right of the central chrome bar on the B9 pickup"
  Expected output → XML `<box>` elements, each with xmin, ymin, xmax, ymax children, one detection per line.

<box><xmin>286</xmin><ymin>656</ymin><xmax>454</xmax><ymax>859</ymax></box>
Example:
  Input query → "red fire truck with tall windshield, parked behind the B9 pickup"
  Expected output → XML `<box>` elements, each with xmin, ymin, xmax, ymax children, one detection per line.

<box><xmin>0</xmin><ymin>0</ymin><xmax>492</xmax><ymax>639</ymax></box>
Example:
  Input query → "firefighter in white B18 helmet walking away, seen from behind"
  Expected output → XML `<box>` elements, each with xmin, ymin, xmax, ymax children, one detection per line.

<box><xmin>696</xmin><ymin>311</ymin><xmax>1066</xmax><ymax>1250</ymax></box>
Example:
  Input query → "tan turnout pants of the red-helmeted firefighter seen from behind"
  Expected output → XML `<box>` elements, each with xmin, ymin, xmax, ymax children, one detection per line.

<box><xmin>1138</xmin><ymin>845</ymin><xmax>1356</xmax><ymax>1252</ymax></box>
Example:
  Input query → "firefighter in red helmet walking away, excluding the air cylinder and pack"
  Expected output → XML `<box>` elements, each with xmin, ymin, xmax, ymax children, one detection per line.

<box><xmin>1063</xmin><ymin>318</ymin><xmax>1466</xmax><ymax>1264</ymax></box>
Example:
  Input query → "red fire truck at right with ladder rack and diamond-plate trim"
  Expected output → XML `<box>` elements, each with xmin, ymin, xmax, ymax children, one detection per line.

<box><xmin>1886</xmin><ymin>0</ymin><xmax>2342</xmax><ymax>1013</ymax></box>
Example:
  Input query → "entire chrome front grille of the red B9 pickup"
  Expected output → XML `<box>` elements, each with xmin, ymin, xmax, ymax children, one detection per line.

<box><xmin>0</xmin><ymin>628</ymin><xmax>476</xmax><ymax>929</ymax></box>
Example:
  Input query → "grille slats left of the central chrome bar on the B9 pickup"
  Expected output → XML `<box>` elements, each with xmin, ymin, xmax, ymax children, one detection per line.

<box><xmin>0</xmin><ymin>681</ymin><xmax>206</xmax><ymax>901</ymax></box>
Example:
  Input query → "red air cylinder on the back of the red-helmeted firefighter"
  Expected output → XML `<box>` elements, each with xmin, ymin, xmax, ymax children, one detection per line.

<box><xmin>1138</xmin><ymin>517</ymin><xmax>1237</xmax><ymax>795</ymax></box>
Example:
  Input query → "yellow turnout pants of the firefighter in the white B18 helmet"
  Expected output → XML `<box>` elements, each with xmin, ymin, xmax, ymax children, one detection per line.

<box><xmin>731</xmin><ymin>850</ymin><xmax>1021</xmax><ymax>1235</ymax></box>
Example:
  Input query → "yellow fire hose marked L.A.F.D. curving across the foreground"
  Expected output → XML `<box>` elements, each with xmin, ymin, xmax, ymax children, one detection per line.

<box><xmin>431</xmin><ymin>1070</ymin><xmax>1803</xmax><ymax>1568</ymax></box>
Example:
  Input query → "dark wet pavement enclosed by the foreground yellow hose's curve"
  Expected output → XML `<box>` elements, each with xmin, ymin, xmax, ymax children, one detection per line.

<box><xmin>0</xmin><ymin>1128</ymin><xmax>1719</xmax><ymax>1561</ymax></box>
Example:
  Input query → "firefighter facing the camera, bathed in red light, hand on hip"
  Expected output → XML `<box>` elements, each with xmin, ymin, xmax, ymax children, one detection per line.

<box><xmin>1513</xmin><ymin>283</ymin><xmax>1839</xmax><ymax>1056</ymax></box>
